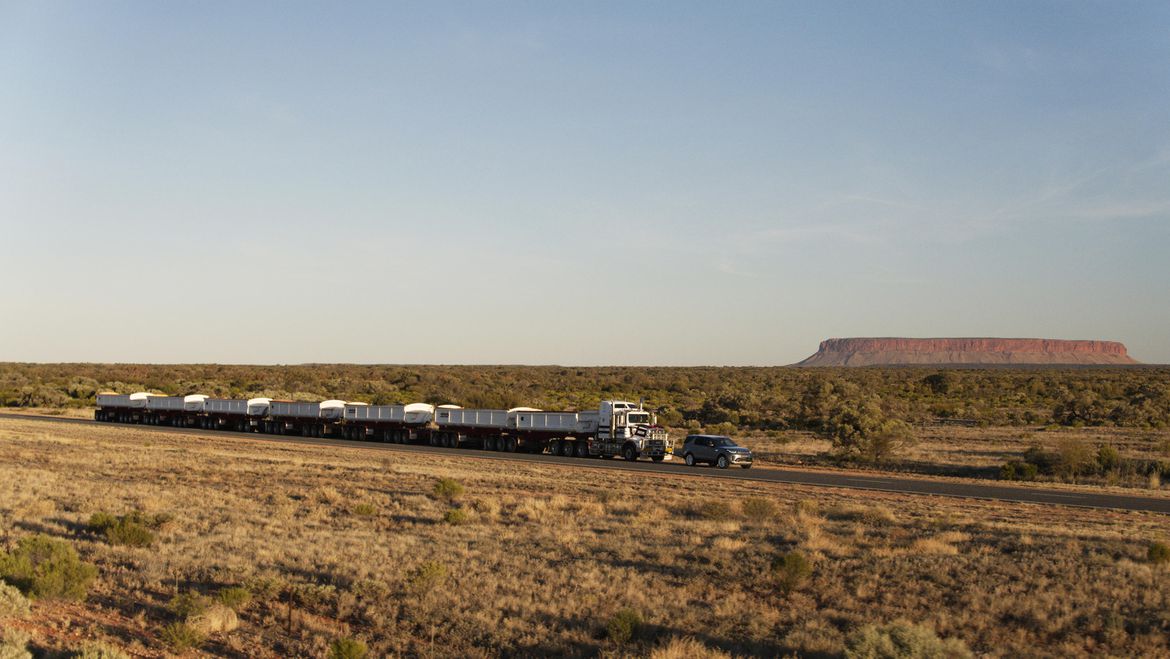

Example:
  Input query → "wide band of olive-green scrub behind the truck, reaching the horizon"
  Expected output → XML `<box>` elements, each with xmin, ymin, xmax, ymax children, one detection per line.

<box><xmin>0</xmin><ymin>363</ymin><xmax>1170</xmax><ymax>433</ymax></box>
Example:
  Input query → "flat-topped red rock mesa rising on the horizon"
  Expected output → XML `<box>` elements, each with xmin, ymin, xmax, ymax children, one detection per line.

<box><xmin>797</xmin><ymin>337</ymin><xmax>1138</xmax><ymax>366</ymax></box>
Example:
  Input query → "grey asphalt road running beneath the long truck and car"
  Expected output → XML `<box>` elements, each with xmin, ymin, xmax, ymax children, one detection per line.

<box><xmin>9</xmin><ymin>414</ymin><xmax>1170</xmax><ymax>514</ymax></box>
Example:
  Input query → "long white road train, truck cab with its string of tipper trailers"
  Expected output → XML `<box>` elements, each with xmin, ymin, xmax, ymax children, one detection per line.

<box><xmin>94</xmin><ymin>392</ymin><xmax>674</xmax><ymax>462</ymax></box>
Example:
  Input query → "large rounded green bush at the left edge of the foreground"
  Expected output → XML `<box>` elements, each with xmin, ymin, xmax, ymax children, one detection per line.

<box><xmin>0</xmin><ymin>535</ymin><xmax>97</xmax><ymax>599</ymax></box>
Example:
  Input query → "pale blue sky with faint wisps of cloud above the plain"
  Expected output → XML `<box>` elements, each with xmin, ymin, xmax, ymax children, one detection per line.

<box><xmin>0</xmin><ymin>0</ymin><xmax>1170</xmax><ymax>364</ymax></box>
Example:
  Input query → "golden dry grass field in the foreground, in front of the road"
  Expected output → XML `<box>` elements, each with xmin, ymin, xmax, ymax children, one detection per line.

<box><xmin>0</xmin><ymin>418</ymin><xmax>1170</xmax><ymax>657</ymax></box>
